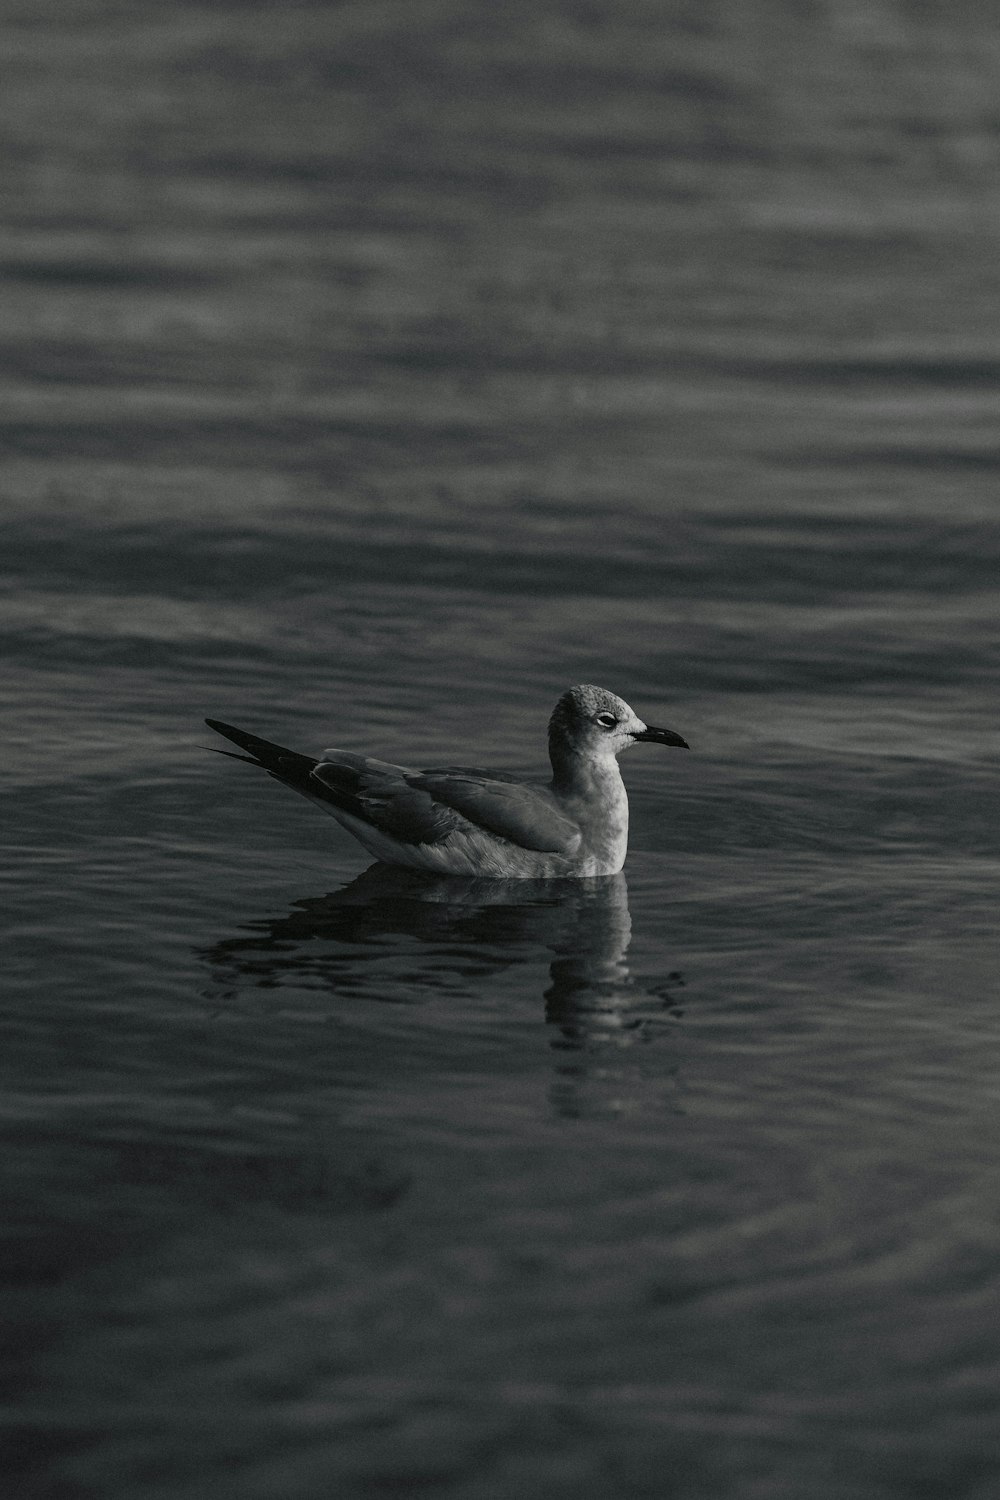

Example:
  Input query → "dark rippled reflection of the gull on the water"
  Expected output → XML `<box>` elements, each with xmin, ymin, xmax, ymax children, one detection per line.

<box><xmin>205</xmin><ymin>864</ymin><xmax>684</xmax><ymax>1115</ymax></box>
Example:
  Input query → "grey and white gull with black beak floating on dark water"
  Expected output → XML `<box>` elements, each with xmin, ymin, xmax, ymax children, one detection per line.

<box><xmin>205</xmin><ymin>683</ymin><xmax>688</xmax><ymax>881</ymax></box>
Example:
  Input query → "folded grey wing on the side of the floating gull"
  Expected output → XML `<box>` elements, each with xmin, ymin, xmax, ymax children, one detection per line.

<box><xmin>312</xmin><ymin>750</ymin><xmax>580</xmax><ymax>854</ymax></box>
